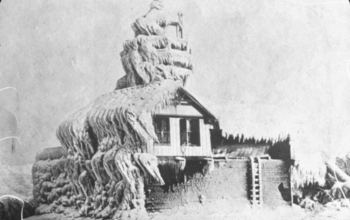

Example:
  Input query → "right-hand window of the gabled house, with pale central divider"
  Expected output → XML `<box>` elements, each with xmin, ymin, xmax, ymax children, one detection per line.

<box><xmin>180</xmin><ymin>118</ymin><xmax>201</xmax><ymax>146</ymax></box>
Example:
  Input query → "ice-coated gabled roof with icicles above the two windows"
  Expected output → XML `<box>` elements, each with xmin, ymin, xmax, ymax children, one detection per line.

<box><xmin>57</xmin><ymin>80</ymin><xmax>215</xmax><ymax>156</ymax></box>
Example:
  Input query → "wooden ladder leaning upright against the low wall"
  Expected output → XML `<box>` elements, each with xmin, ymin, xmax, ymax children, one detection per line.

<box><xmin>249</xmin><ymin>157</ymin><xmax>263</xmax><ymax>206</ymax></box>
